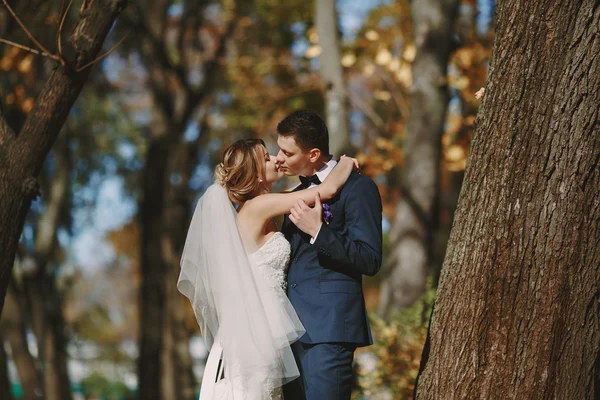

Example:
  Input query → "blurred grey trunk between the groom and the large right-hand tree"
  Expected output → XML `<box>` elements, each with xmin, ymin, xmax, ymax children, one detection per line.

<box><xmin>379</xmin><ymin>0</ymin><xmax>459</xmax><ymax>317</ymax></box>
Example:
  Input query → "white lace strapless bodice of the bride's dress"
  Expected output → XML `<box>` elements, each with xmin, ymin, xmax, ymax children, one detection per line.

<box><xmin>251</xmin><ymin>232</ymin><xmax>291</xmax><ymax>289</ymax></box>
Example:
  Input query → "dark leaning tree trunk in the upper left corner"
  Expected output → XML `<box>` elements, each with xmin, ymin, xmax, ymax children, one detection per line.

<box><xmin>0</xmin><ymin>0</ymin><xmax>126</xmax><ymax>312</ymax></box>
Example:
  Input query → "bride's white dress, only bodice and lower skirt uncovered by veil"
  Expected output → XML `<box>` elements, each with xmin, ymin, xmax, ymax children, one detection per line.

<box><xmin>200</xmin><ymin>232</ymin><xmax>291</xmax><ymax>400</ymax></box>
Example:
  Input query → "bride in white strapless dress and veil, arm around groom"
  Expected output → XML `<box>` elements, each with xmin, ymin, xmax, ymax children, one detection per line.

<box><xmin>177</xmin><ymin>139</ymin><xmax>358</xmax><ymax>400</ymax></box>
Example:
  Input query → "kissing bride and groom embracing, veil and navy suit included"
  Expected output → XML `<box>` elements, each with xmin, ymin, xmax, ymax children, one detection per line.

<box><xmin>177</xmin><ymin>110</ymin><xmax>382</xmax><ymax>400</ymax></box>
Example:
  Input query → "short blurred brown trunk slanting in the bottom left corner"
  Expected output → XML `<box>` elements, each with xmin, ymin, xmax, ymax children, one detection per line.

<box><xmin>0</xmin><ymin>283</ymin><xmax>43</xmax><ymax>400</ymax></box>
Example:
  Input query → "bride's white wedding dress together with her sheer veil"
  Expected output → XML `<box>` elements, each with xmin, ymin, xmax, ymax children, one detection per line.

<box><xmin>177</xmin><ymin>184</ymin><xmax>305</xmax><ymax>400</ymax></box>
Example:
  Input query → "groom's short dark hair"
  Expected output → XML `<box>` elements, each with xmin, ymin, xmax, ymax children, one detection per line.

<box><xmin>277</xmin><ymin>110</ymin><xmax>329</xmax><ymax>155</ymax></box>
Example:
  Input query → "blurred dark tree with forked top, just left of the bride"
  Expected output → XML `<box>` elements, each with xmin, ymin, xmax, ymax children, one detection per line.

<box><xmin>117</xmin><ymin>0</ymin><xmax>238</xmax><ymax>399</ymax></box>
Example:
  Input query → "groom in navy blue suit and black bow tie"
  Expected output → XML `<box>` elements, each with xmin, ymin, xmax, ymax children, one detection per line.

<box><xmin>277</xmin><ymin>110</ymin><xmax>382</xmax><ymax>400</ymax></box>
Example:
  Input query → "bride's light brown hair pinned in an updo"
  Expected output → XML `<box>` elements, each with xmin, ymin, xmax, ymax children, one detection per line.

<box><xmin>215</xmin><ymin>139</ymin><xmax>266</xmax><ymax>204</ymax></box>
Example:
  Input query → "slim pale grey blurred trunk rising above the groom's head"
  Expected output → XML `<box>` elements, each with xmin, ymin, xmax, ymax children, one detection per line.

<box><xmin>315</xmin><ymin>0</ymin><xmax>350</xmax><ymax>156</ymax></box>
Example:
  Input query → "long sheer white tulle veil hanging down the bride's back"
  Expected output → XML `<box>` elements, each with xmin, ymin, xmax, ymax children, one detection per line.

<box><xmin>177</xmin><ymin>183</ymin><xmax>304</xmax><ymax>390</ymax></box>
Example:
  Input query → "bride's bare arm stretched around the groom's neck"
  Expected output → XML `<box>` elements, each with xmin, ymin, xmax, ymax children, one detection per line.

<box><xmin>245</xmin><ymin>157</ymin><xmax>358</xmax><ymax>219</ymax></box>
